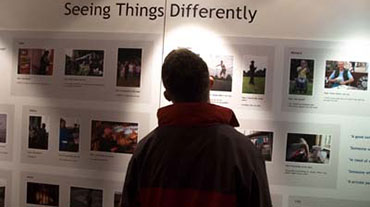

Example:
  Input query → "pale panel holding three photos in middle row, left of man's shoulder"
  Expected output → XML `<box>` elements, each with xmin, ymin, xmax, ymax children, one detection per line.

<box><xmin>19</xmin><ymin>106</ymin><xmax>149</xmax><ymax>172</ymax></box>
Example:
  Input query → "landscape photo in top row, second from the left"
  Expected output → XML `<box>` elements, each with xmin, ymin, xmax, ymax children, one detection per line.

<box><xmin>65</xmin><ymin>50</ymin><xmax>104</xmax><ymax>77</ymax></box>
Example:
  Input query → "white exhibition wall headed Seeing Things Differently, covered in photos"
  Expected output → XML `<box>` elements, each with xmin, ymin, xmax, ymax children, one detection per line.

<box><xmin>0</xmin><ymin>0</ymin><xmax>370</xmax><ymax>207</ymax></box>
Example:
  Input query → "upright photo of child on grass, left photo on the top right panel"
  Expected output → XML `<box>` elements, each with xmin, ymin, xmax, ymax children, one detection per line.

<box><xmin>289</xmin><ymin>58</ymin><xmax>315</xmax><ymax>96</ymax></box>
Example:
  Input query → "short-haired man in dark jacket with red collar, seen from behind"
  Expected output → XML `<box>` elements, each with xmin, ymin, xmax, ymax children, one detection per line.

<box><xmin>121</xmin><ymin>49</ymin><xmax>272</xmax><ymax>207</ymax></box>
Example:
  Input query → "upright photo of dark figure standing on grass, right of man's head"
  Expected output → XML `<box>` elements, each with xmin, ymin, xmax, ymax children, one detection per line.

<box><xmin>242</xmin><ymin>56</ymin><xmax>268</xmax><ymax>94</ymax></box>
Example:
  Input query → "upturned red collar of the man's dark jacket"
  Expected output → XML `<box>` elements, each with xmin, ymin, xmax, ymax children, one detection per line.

<box><xmin>157</xmin><ymin>103</ymin><xmax>239</xmax><ymax>127</ymax></box>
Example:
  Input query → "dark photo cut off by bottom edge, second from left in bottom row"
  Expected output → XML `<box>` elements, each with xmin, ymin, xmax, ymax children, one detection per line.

<box><xmin>70</xmin><ymin>187</ymin><xmax>103</xmax><ymax>207</ymax></box>
